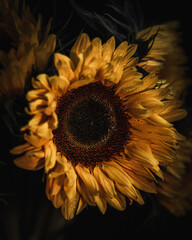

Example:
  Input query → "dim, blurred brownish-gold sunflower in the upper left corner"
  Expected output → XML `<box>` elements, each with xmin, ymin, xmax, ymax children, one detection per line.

<box><xmin>0</xmin><ymin>0</ymin><xmax>56</xmax><ymax>100</ymax></box>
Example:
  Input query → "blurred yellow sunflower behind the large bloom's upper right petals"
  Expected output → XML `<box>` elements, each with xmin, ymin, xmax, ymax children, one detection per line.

<box><xmin>137</xmin><ymin>22</ymin><xmax>191</xmax><ymax>98</ymax></box>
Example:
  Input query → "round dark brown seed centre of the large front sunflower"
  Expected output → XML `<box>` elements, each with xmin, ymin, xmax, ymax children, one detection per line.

<box><xmin>53</xmin><ymin>83</ymin><xmax>130</xmax><ymax>166</ymax></box>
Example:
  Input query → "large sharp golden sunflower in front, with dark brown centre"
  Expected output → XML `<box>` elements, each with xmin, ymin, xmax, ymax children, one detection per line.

<box><xmin>11</xmin><ymin>19</ymin><xmax>190</xmax><ymax>219</ymax></box>
